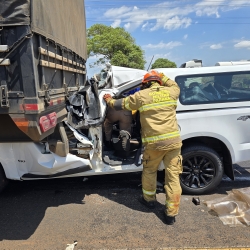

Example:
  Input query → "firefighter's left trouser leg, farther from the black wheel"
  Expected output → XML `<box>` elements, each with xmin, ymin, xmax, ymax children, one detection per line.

<box><xmin>142</xmin><ymin>149</ymin><xmax>165</xmax><ymax>202</ymax></box>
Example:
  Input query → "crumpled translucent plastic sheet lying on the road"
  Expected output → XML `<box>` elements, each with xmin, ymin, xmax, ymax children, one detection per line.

<box><xmin>204</xmin><ymin>187</ymin><xmax>250</xmax><ymax>226</ymax></box>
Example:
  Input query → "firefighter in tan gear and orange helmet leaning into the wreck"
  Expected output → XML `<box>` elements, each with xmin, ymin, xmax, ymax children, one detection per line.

<box><xmin>103</xmin><ymin>71</ymin><xmax>182</xmax><ymax>225</ymax></box>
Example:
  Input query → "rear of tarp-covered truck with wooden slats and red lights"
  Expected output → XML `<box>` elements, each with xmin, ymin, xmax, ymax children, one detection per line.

<box><xmin>0</xmin><ymin>0</ymin><xmax>87</xmax><ymax>142</ymax></box>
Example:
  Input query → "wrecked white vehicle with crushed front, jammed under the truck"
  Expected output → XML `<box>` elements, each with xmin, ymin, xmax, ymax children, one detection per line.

<box><xmin>0</xmin><ymin>65</ymin><xmax>250</xmax><ymax>194</ymax></box>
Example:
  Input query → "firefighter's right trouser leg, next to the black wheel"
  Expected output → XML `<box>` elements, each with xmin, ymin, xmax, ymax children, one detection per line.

<box><xmin>163</xmin><ymin>148</ymin><xmax>182</xmax><ymax>216</ymax></box>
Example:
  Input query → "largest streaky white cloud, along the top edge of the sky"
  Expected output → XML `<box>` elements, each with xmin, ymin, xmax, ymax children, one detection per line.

<box><xmin>99</xmin><ymin>0</ymin><xmax>249</xmax><ymax>31</ymax></box>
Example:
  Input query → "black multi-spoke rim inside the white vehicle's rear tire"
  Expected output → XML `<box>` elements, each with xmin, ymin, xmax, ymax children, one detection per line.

<box><xmin>181</xmin><ymin>154</ymin><xmax>216</xmax><ymax>189</ymax></box>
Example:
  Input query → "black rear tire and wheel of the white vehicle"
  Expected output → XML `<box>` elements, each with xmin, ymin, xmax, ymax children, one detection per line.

<box><xmin>180</xmin><ymin>145</ymin><xmax>223</xmax><ymax>195</ymax></box>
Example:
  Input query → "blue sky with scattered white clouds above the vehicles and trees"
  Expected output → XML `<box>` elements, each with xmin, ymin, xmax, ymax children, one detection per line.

<box><xmin>85</xmin><ymin>0</ymin><xmax>250</xmax><ymax>76</ymax></box>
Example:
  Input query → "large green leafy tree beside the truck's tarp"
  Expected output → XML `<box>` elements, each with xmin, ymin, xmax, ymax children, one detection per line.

<box><xmin>87</xmin><ymin>24</ymin><xmax>146</xmax><ymax>69</ymax></box>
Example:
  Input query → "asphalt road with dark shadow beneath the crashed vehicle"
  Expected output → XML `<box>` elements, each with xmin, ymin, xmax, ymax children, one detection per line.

<box><xmin>0</xmin><ymin>162</ymin><xmax>250</xmax><ymax>250</ymax></box>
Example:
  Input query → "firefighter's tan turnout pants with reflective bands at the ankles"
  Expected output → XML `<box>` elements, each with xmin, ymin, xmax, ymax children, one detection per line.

<box><xmin>142</xmin><ymin>147</ymin><xmax>182</xmax><ymax>216</ymax></box>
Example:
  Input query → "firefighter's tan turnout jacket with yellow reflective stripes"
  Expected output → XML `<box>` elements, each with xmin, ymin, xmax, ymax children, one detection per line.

<box><xmin>108</xmin><ymin>75</ymin><xmax>181</xmax><ymax>150</ymax></box>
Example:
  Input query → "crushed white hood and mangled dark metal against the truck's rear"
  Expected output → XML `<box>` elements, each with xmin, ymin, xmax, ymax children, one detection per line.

<box><xmin>67</xmin><ymin>65</ymin><xmax>147</xmax><ymax>129</ymax></box>
